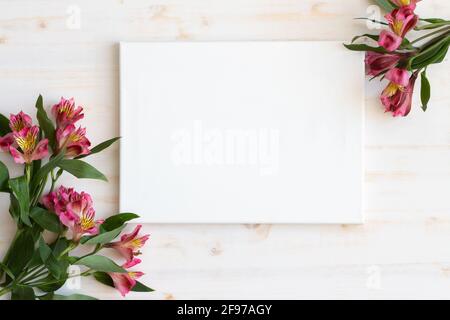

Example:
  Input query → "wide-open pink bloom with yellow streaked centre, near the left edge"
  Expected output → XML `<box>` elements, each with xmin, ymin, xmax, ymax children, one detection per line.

<box><xmin>9</xmin><ymin>126</ymin><xmax>48</xmax><ymax>164</ymax></box>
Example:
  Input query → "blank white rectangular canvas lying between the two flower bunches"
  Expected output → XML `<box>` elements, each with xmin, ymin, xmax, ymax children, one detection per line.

<box><xmin>120</xmin><ymin>41</ymin><xmax>364</xmax><ymax>223</ymax></box>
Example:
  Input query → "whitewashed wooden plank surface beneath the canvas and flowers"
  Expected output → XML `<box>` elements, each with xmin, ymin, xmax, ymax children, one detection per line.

<box><xmin>0</xmin><ymin>0</ymin><xmax>450</xmax><ymax>299</ymax></box>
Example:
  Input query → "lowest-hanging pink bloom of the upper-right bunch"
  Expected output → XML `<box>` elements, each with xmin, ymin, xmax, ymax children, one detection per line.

<box><xmin>381</xmin><ymin>69</ymin><xmax>417</xmax><ymax>117</ymax></box>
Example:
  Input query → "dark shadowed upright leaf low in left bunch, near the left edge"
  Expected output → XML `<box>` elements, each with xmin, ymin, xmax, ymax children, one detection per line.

<box><xmin>7</xmin><ymin>228</ymin><xmax>35</xmax><ymax>276</ymax></box>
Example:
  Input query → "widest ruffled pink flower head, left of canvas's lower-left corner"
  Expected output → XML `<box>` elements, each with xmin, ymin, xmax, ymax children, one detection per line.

<box><xmin>42</xmin><ymin>186</ymin><xmax>103</xmax><ymax>242</ymax></box>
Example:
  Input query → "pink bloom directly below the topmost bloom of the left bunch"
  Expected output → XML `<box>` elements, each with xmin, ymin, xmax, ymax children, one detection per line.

<box><xmin>56</xmin><ymin>124</ymin><xmax>91</xmax><ymax>157</ymax></box>
